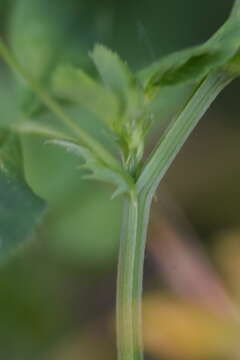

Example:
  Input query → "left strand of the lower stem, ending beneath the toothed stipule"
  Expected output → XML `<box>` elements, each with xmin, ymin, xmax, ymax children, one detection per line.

<box><xmin>116</xmin><ymin>196</ymin><xmax>138</xmax><ymax>360</ymax></box>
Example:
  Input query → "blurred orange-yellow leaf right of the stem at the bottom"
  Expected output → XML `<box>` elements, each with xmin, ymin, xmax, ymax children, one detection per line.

<box><xmin>143</xmin><ymin>294</ymin><xmax>239</xmax><ymax>360</ymax></box>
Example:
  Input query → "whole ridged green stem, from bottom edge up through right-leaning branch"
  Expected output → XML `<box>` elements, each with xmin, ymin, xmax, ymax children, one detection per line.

<box><xmin>117</xmin><ymin>72</ymin><xmax>235</xmax><ymax>360</ymax></box>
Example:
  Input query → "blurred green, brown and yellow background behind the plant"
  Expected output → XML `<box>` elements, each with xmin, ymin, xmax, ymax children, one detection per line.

<box><xmin>0</xmin><ymin>0</ymin><xmax>240</xmax><ymax>360</ymax></box>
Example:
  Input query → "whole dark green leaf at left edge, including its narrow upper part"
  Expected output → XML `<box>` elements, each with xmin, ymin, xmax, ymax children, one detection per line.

<box><xmin>0</xmin><ymin>130</ymin><xmax>45</xmax><ymax>263</ymax></box>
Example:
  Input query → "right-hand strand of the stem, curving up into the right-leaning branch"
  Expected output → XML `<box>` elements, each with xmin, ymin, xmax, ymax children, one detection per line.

<box><xmin>129</xmin><ymin>11</ymin><xmax>240</xmax><ymax>352</ymax></box>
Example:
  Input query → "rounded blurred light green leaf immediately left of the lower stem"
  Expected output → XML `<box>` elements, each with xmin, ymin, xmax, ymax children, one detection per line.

<box><xmin>46</xmin><ymin>183</ymin><xmax>123</xmax><ymax>268</ymax></box>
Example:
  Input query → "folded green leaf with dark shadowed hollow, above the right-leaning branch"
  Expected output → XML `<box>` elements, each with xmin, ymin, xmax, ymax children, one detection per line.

<box><xmin>138</xmin><ymin>14</ymin><xmax>240</xmax><ymax>91</ymax></box>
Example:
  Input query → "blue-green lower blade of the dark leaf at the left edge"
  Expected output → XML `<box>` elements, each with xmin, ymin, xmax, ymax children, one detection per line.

<box><xmin>0</xmin><ymin>169</ymin><xmax>45</xmax><ymax>264</ymax></box>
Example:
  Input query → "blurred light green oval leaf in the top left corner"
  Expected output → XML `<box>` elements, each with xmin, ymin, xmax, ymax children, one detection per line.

<box><xmin>9</xmin><ymin>0</ymin><xmax>60</xmax><ymax>114</ymax></box>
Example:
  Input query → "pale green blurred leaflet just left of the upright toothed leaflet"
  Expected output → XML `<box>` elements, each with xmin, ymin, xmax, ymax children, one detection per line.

<box><xmin>52</xmin><ymin>66</ymin><xmax>119</xmax><ymax>125</ymax></box>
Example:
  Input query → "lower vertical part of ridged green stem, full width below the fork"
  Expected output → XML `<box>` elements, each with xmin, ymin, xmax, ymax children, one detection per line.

<box><xmin>117</xmin><ymin>192</ymin><xmax>151</xmax><ymax>360</ymax></box>
